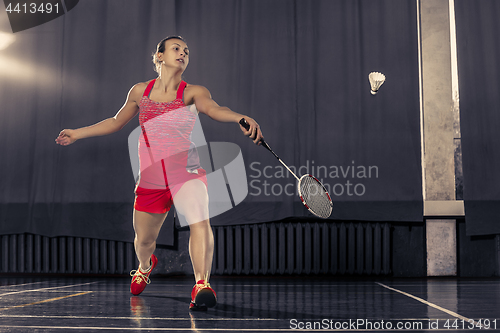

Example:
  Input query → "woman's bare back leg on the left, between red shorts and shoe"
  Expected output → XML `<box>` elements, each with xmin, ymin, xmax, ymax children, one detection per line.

<box><xmin>134</xmin><ymin>209</ymin><xmax>167</xmax><ymax>272</ymax></box>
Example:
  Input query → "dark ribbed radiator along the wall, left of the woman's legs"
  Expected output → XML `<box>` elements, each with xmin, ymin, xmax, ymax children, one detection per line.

<box><xmin>0</xmin><ymin>234</ymin><xmax>137</xmax><ymax>274</ymax></box>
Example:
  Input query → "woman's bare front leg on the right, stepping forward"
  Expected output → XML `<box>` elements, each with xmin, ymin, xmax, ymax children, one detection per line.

<box><xmin>174</xmin><ymin>179</ymin><xmax>214</xmax><ymax>282</ymax></box>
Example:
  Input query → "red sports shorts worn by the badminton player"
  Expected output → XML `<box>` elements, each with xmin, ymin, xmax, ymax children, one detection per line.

<box><xmin>134</xmin><ymin>169</ymin><xmax>208</xmax><ymax>214</ymax></box>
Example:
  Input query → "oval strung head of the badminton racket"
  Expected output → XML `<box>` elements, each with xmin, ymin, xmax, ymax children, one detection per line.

<box><xmin>299</xmin><ymin>176</ymin><xmax>332</xmax><ymax>218</ymax></box>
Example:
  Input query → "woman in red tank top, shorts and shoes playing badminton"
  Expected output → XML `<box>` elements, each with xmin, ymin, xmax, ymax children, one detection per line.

<box><xmin>56</xmin><ymin>36</ymin><xmax>263</xmax><ymax>310</ymax></box>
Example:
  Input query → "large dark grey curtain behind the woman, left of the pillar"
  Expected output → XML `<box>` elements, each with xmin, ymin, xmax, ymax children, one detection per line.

<box><xmin>0</xmin><ymin>0</ymin><xmax>426</xmax><ymax>243</ymax></box>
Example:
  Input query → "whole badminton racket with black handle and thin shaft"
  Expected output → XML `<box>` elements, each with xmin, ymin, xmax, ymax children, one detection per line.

<box><xmin>240</xmin><ymin>118</ymin><xmax>333</xmax><ymax>219</ymax></box>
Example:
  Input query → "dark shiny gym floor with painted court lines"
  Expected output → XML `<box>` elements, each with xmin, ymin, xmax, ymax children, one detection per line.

<box><xmin>0</xmin><ymin>275</ymin><xmax>500</xmax><ymax>332</ymax></box>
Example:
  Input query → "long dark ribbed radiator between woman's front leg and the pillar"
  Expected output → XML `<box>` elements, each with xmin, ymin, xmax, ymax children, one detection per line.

<box><xmin>212</xmin><ymin>222</ymin><xmax>391</xmax><ymax>275</ymax></box>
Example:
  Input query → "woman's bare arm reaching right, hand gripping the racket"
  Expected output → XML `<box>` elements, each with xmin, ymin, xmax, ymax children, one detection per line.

<box><xmin>192</xmin><ymin>86</ymin><xmax>264</xmax><ymax>144</ymax></box>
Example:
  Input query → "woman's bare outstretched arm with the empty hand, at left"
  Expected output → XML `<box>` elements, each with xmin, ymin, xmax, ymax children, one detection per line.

<box><xmin>56</xmin><ymin>83</ymin><xmax>145</xmax><ymax>146</ymax></box>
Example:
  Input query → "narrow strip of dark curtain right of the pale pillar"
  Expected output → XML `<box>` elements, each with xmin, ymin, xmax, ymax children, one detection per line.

<box><xmin>455</xmin><ymin>0</ymin><xmax>500</xmax><ymax>235</ymax></box>
